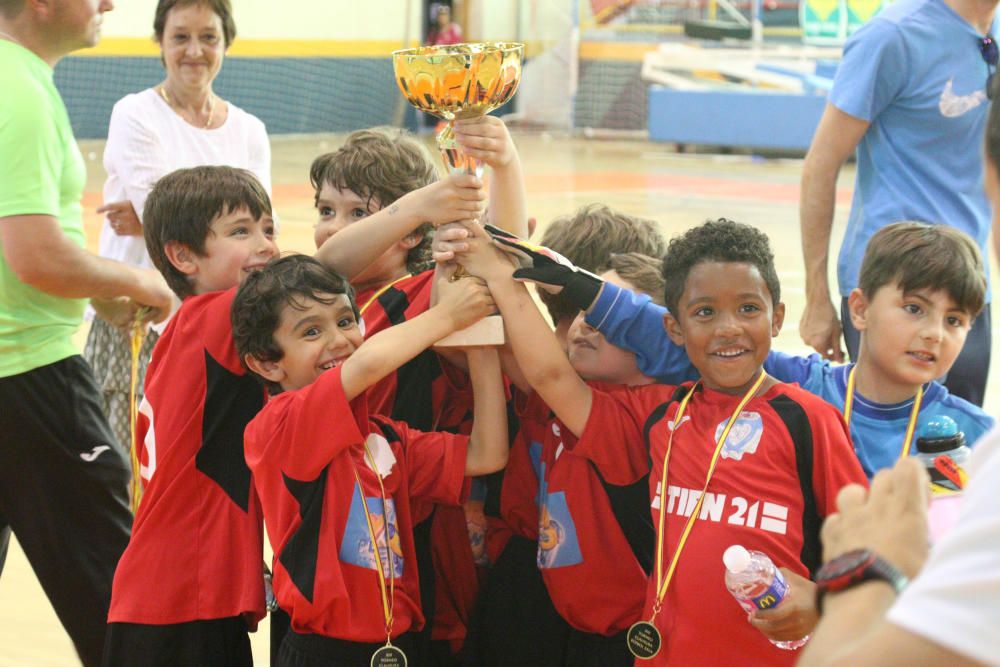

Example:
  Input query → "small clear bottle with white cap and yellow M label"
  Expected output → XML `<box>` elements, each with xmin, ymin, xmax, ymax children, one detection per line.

<box><xmin>722</xmin><ymin>544</ymin><xmax>809</xmax><ymax>651</ymax></box>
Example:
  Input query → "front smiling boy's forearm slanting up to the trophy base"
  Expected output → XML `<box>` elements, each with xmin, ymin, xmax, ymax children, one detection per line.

<box><xmin>341</xmin><ymin>268</ymin><xmax>496</xmax><ymax>400</ymax></box>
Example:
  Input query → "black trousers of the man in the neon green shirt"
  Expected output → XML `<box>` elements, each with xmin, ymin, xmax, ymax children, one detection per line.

<box><xmin>0</xmin><ymin>356</ymin><xmax>132</xmax><ymax>666</ymax></box>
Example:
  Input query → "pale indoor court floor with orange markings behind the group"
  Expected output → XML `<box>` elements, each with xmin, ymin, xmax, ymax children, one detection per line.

<box><xmin>0</xmin><ymin>133</ymin><xmax>1000</xmax><ymax>667</ymax></box>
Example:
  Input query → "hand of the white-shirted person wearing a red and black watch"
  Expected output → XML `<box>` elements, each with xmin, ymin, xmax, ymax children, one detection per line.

<box><xmin>821</xmin><ymin>457</ymin><xmax>930</xmax><ymax>579</ymax></box>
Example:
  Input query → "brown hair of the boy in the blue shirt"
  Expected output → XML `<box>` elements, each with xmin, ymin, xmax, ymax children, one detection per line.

<box><xmin>858</xmin><ymin>222</ymin><xmax>986</xmax><ymax>317</ymax></box>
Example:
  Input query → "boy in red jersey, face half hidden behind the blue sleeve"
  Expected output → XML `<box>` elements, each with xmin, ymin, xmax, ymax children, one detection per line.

<box><xmin>471</xmin><ymin>253</ymin><xmax>663</xmax><ymax>667</ymax></box>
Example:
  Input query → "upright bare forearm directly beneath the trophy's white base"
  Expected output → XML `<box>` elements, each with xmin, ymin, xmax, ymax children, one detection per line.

<box><xmin>465</xmin><ymin>347</ymin><xmax>510</xmax><ymax>477</ymax></box>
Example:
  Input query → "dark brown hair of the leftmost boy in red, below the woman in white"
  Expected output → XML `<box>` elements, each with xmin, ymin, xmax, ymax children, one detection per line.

<box><xmin>142</xmin><ymin>167</ymin><xmax>271</xmax><ymax>299</ymax></box>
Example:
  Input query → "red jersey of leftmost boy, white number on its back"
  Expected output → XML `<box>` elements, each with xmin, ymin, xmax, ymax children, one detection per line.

<box><xmin>108</xmin><ymin>289</ymin><xmax>264</xmax><ymax>625</ymax></box>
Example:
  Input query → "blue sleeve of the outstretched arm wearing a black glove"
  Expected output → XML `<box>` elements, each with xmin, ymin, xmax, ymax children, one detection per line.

<box><xmin>586</xmin><ymin>282</ymin><xmax>698</xmax><ymax>384</ymax></box>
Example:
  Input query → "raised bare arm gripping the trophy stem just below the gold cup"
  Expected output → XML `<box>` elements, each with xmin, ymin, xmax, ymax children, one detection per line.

<box><xmin>455</xmin><ymin>116</ymin><xmax>530</xmax><ymax>238</ymax></box>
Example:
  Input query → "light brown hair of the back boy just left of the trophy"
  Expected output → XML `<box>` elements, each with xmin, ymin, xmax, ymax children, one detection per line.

<box><xmin>309</xmin><ymin>127</ymin><xmax>437</xmax><ymax>273</ymax></box>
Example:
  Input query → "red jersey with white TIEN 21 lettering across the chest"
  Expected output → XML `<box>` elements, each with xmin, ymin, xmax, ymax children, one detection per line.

<box><xmin>574</xmin><ymin>384</ymin><xmax>866</xmax><ymax>666</ymax></box>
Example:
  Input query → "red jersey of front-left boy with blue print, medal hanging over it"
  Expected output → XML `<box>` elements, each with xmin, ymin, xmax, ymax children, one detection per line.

<box><xmin>245</xmin><ymin>368</ymin><xmax>468</xmax><ymax>642</ymax></box>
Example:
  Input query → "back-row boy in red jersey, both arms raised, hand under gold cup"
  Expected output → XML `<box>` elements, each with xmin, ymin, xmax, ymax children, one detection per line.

<box><xmin>310</xmin><ymin>117</ymin><xmax>527</xmax><ymax>665</ymax></box>
